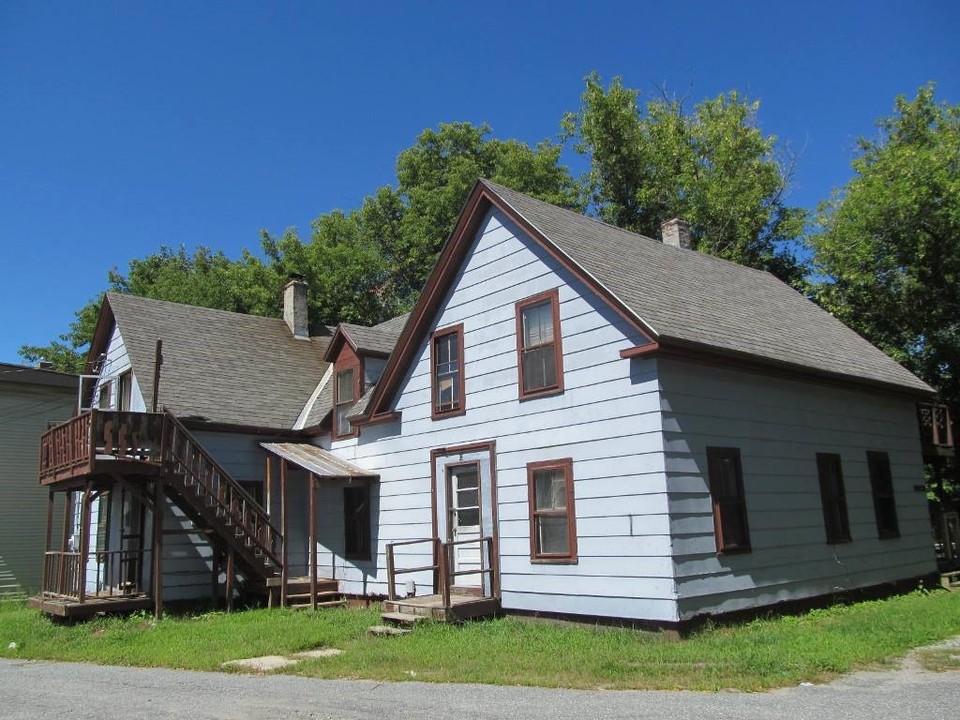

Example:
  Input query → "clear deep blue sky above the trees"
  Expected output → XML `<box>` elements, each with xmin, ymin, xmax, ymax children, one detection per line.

<box><xmin>0</xmin><ymin>0</ymin><xmax>960</xmax><ymax>362</ymax></box>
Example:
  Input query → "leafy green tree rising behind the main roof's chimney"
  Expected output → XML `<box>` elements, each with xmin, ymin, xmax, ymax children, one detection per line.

<box><xmin>562</xmin><ymin>73</ymin><xmax>805</xmax><ymax>285</ymax></box>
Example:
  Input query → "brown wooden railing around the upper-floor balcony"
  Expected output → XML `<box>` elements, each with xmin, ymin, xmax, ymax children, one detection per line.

<box><xmin>40</xmin><ymin>410</ymin><xmax>163</xmax><ymax>484</ymax></box>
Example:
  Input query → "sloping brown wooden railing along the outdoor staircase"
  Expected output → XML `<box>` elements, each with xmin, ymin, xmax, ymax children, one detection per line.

<box><xmin>163</xmin><ymin>413</ymin><xmax>283</xmax><ymax>570</ymax></box>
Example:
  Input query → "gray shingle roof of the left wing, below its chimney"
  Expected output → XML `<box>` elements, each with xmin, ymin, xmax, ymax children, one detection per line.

<box><xmin>107</xmin><ymin>293</ymin><xmax>330</xmax><ymax>428</ymax></box>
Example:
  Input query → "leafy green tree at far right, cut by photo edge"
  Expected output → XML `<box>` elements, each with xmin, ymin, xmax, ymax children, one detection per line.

<box><xmin>810</xmin><ymin>85</ymin><xmax>960</xmax><ymax>418</ymax></box>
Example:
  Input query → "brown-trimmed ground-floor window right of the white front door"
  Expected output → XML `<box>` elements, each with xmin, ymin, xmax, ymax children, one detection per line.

<box><xmin>527</xmin><ymin>458</ymin><xmax>577</xmax><ymax>563</ymax></box>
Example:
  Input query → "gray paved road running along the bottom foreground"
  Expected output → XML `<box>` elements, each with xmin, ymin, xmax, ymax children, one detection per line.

<box><xmin>0</xmin><ymin>660</ymin><xmax>960</xmax><ymax>720</ymax></box>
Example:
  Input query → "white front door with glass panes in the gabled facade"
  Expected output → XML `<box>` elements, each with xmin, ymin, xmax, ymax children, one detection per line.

<box><xmin>447</xmin><ymin>462</ymin><xmax>483</xmax><ymax>588</ymax></box>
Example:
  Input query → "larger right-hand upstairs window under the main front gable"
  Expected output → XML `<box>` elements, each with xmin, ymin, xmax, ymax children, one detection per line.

<box><xmin>516</xmin><ymin>289</ymin><xmax>563</xmax><ymax>400</ymax></box>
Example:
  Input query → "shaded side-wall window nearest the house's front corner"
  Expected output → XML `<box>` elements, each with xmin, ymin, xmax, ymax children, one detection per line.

<box><xmin>707</xmin><ymin>447</ymin><xmax>750</xmax><ymax>553</ymax></box>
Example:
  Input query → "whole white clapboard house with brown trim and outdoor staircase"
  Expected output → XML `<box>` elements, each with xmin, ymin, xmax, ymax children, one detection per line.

<box><xmin>35</xmin><ymin>181</ymin><xmax>936</xmax><ymax>625</ymax></box>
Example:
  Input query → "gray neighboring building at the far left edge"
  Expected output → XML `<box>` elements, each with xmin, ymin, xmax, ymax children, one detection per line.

<box><xmin>0</xmin><ymin>363</ymin><xmax>77</xmax><ymax>596</ymax></box>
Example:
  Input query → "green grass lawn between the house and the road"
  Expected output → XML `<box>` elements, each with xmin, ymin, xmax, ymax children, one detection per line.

<box><xmin>0</xmin><ymin>591</ymin><xmax>960</xmax><ymax>690</ymax></box>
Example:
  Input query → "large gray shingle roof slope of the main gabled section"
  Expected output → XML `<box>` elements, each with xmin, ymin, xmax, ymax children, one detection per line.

<box><xmin>481</xmin><ymin>180</ymin><xmax>932</xmax><ymax>392</ymax></box>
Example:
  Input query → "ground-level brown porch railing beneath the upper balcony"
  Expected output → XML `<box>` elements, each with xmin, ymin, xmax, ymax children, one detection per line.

<box><xmin>43</xmin><ymin>550</ymin><xmax>144</xmax><ymax>602</ymax></box>
